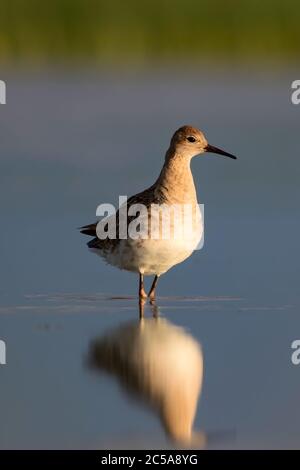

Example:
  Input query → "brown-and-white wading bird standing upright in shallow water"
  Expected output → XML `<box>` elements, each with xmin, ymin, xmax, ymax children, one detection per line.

<box><xmin>80</xmin><ymin>125</ymin><xmax>237</xmax><ymax>301</ymax></box>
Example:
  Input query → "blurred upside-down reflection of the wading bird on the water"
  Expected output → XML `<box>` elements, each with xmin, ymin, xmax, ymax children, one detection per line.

<box><xmin>89</xmin><ymin>302</ymin><xmax>206</xmax><ymax>448</ymax></box>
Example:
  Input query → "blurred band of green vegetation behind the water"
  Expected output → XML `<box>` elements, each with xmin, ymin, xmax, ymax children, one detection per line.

<box><xmin>0</xmin><ymin>0</ymin><xmax>300</xmax><ymax>63</ymax></box>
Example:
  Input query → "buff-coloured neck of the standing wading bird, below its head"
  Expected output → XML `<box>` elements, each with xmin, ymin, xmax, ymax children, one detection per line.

<box><xmin>156</xmin><ymin>149</ymin><xmax>197</xmax><ymax>204</ymax></box>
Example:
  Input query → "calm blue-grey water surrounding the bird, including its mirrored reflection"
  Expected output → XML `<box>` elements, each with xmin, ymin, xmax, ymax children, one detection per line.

<box><xmin>0</xmin><ymin>70</ymin><xmax>300</xmax><ymax>448</ymax></box>
